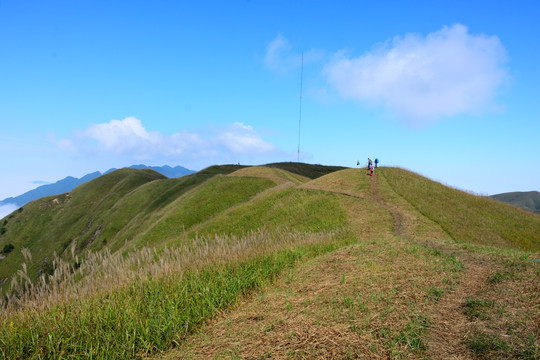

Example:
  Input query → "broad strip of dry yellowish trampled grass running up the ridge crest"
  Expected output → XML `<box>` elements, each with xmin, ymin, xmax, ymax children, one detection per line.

<box><xmin>154</xmin><ymin>169</ymin><xmax>534</xmax><ymax>359</ymax></box>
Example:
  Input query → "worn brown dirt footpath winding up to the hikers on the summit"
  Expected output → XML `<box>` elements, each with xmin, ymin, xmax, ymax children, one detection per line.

<box><xmin>304</xmin><ymin>169</ymin><xmax>494</xmax><ymax>359</ymax></box>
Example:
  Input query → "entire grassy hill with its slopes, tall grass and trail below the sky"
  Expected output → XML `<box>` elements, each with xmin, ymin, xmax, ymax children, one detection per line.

<box><xmin>0</xmin><ymin>163</ymin><xmax>540</xmax><ymax>359</ymax></box>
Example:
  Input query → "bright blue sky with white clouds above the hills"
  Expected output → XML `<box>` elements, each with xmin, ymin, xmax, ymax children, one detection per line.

<box><xmin>0</xmin><ymin>0</ymin><xmax>540</xmax><ymax>214</ymax></box>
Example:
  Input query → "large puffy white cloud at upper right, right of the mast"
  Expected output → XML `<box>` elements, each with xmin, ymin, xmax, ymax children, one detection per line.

<box><xmin>323</xmin><ymin>24</ymin><xmax>509</xmax><ymax>124</ymax></box>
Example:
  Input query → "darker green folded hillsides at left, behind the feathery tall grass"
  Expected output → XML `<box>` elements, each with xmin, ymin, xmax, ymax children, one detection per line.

<box><xmin>0</xmin><ymin>165</ymin><xmax>255</xmax><ymax>291</ymax></box>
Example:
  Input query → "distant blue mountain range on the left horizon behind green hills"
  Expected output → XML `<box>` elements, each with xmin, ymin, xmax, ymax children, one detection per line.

<box><xmin>0</xmin><ymin>164</ymin><xmax>195</xmax><ymax>207</ymax></box>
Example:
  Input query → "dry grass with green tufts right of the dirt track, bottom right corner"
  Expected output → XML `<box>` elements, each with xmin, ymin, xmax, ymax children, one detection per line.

<box><xmin>461</xmin><ymin>255</ymin><xmax>540</xmax><ymax>359</ymax></box>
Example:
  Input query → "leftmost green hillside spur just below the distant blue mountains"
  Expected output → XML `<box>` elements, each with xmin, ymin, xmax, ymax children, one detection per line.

<box><xmin>0</xmin><ymin>169</ymin><xmax>164</xmax><ymax>289</ymax></box>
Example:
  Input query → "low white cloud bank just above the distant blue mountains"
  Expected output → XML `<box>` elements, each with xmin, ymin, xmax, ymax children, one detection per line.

<box><xmin>56</xmin><ymin>117</ymin><xmax>278</xmax><ymax>164</ymax></box>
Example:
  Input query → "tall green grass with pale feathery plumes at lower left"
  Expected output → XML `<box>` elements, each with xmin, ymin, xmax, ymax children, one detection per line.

<box><xmin>0</xmin><ymin>226</ymin><xmax>353</xmax><ymax>359</ymax></box>
